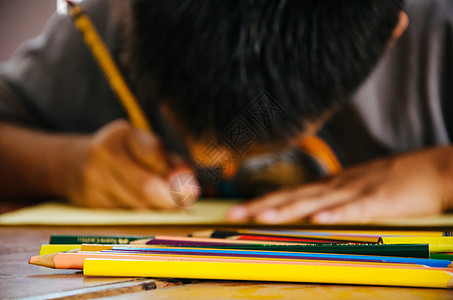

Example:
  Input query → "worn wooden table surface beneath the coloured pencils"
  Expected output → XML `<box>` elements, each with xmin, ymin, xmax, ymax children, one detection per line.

<box><xmin>0</xmin><ymin>226</ymin><xmax>453</xmax><ymax>299</ymax></box>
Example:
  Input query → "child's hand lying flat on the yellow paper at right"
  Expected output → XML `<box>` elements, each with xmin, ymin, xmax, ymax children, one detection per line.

<box><xmin>229</xmin><ymin>146</ymin><xmax>453</xmax><ymax>223</ymax></box>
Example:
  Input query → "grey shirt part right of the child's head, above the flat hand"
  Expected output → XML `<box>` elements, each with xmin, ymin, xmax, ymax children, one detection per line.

<box><xmin>329</xmin><ymin>0</ymin><xmax>453</xmax><ymax>163</ymax></box>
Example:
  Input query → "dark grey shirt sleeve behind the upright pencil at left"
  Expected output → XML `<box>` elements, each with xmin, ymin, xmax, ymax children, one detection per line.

<box><xmin>0</xmin><ymin>0</ymin><xmax>124</xmax><ymax>132</ymax></box>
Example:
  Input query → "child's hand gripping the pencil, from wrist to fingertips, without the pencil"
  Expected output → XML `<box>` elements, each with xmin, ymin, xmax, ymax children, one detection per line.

<box><xmin>64</xmin><ymin>120</ymin><xmax>196</xmax><ymax>209</ymax></box>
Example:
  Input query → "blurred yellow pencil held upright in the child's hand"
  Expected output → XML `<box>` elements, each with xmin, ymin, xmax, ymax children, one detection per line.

<box><xmin>66</xmin><ymin>1</ymin><xmax>152</xmax><ymax>132</ymax></box>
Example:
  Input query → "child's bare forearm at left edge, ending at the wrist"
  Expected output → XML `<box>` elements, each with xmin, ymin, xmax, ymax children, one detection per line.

<box><xmin>0</xmin><ymin>122</ymin><xmax>88</xmax><ymax>197</ymax></box>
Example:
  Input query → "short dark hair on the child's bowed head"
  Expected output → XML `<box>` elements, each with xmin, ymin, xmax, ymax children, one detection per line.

<box><xmin>124</xmin><ymin>0</ymin><xmax>403</xmax><ymax>142</ymax></box>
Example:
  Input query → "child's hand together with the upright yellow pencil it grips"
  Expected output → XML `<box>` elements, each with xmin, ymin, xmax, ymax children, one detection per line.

<box><xmin>65</xmin><ymin>1</ymin><xmax>199</xmax><ymax>208</ymax></box>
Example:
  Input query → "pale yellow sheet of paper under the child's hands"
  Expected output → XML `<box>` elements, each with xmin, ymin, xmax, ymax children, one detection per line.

<box><xmin>0</xmin><ymin>199</ymin><xmax>453</xmax><ymax>228</ymax></box>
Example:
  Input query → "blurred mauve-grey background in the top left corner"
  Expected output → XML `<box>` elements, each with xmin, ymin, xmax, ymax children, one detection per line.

<box><xmin>0</xmin><ymin>0</ymin><xmax>57</xmax><ymax>62</ymax></box>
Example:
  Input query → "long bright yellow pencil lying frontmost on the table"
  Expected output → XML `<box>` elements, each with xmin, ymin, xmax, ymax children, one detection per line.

<box><xmin>83</xmin><ymin>259</ymin><xmax>453</xmax><ymax>288</ymax></box>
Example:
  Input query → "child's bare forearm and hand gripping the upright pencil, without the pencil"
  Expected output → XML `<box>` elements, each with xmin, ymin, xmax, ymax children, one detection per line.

<box><xmin>0</xmin><ymin>121</ymin><xmax>196</xmax><ymax>208</ymax></box>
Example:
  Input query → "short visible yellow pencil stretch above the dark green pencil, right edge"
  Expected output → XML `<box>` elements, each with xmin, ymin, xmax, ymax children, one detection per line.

<box><xmin>382</xmin><ymin>236</ymin><xmax>453</xmax><ymax>252</ymax></box>
